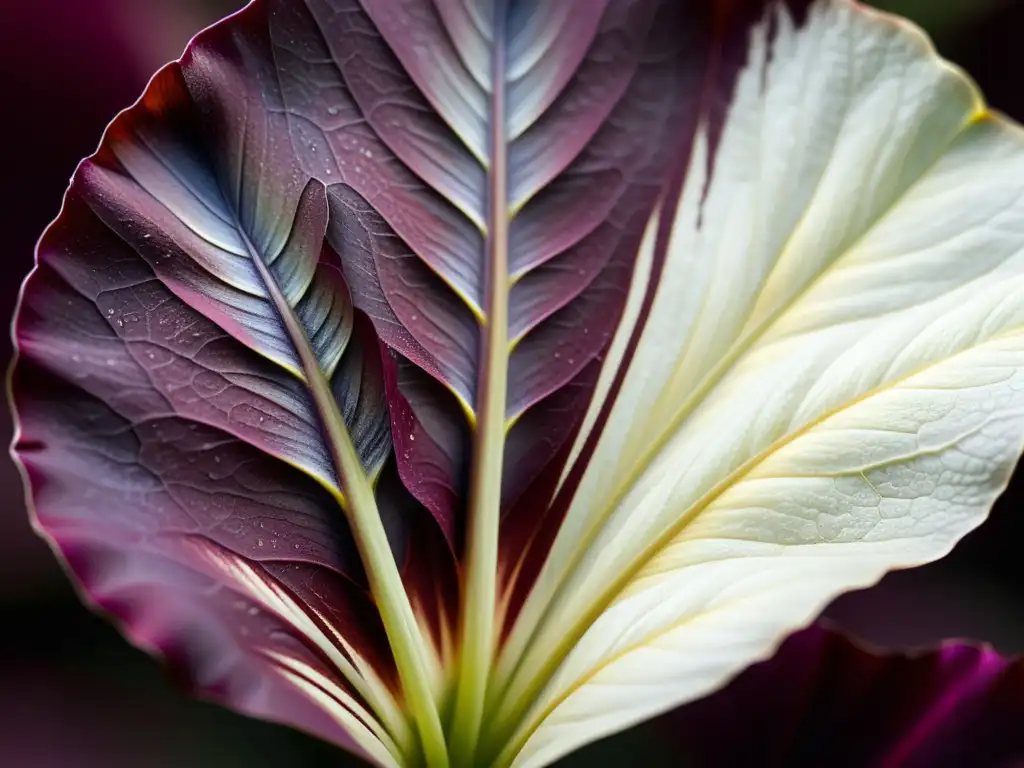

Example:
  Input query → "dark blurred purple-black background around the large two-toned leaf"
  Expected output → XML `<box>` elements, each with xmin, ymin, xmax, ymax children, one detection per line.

<box><xmin>0</xmin><ymin>0</ymin><xmax>1024</xmax><ymax>768</ymax></box>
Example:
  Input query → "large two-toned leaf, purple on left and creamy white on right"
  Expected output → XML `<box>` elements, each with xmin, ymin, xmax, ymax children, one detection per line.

<box><xmin>13</xmin><ymin>0</ymin><xmax>1024</xmax><ymax>766</ymax></box>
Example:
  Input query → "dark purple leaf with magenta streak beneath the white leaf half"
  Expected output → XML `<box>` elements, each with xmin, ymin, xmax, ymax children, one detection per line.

<box><xmin>648</xmin><ymin>627</ymin><xmax>1024</xmax><ymax>768</ymax></box>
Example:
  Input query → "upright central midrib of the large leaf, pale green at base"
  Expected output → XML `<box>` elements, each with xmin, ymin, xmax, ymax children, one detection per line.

<box><xmin>451</xmin><ymin>0</ymin><xmax>509</xmax><ymax>766</ymax></box>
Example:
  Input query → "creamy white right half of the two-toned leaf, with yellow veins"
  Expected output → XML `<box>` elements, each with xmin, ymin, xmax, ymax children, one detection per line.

<box><xmin>497</xmin><ymin>0</ymin><xmax>1024</xmax><ymax>766</ymax></box>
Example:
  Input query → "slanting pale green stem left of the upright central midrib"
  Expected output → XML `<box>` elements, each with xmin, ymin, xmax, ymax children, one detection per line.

<box><xmin>245</xmin><ymin>226</ymin><xmax>449</xmax><ymax>768</ymax></box>
